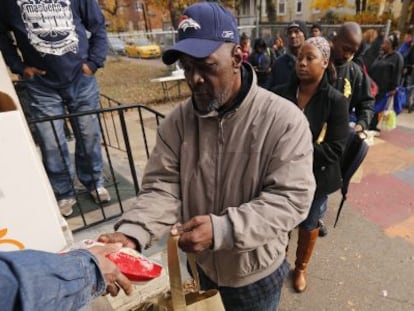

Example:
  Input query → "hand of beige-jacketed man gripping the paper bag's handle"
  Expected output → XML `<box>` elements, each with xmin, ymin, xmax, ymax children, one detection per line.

<box><xmin>175</xmin><ymin>215</ymin><xmax>213</xmax><ymax>253</ymax></box>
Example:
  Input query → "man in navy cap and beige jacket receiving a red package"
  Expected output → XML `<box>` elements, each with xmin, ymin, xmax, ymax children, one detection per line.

<box><xmin>100</xmin><ymin>2</ymin><xmax>315</xmax><ymax>311</ymax></box>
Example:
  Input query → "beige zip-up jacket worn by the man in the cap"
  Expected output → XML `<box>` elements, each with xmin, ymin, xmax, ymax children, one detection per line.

<box><xmin>115</xmin><ymin>71</ymin><xmax>315</xmax><ymax>287</ymax></box>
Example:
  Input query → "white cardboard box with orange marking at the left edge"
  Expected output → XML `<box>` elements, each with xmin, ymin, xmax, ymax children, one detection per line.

<box><xmin>0</xmin><ymin>53</ymin><xmax>66</xmax><ymax>252</ymax></box>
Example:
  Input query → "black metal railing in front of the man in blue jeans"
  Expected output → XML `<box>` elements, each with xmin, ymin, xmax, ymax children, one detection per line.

<box><xmin>15</xmin><ymin>82</ymin><xmax>164</xmax><ymax>232</ymax></box>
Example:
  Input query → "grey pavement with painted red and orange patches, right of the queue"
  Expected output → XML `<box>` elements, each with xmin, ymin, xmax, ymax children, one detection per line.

<box><xmin>75</xmin><ymin>108</ymin><xmax>414</xmax><ymax>311</ymax></box>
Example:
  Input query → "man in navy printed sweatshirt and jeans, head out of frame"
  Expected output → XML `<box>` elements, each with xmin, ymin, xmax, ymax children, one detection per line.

<box><xmin>0</xmin><ymin>0</ymin><xmax>110</xmax><ymax>216</ymax></box>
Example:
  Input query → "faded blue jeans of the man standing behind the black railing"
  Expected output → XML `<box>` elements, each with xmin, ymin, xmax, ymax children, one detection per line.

<box><xmin>27</xmin><ymin>74</ymin><xmax>103</xmax><ymax>200</ymax></box>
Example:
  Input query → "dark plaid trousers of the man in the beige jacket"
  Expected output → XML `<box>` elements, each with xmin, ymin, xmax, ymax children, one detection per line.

<box><xmin>193</xmin><ymin>260</ymin><xmax>289</xmax><ymax>311</ymax></box>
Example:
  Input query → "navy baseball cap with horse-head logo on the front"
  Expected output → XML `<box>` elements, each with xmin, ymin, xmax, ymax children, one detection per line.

<box><xmin>162</xmin><ymin>2</ymin><xmax>239</xmax><ymax>65</ymax></box>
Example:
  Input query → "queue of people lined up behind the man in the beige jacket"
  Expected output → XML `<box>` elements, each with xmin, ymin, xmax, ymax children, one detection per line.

<box><xmin>236</xmin><ymin>20</ymin><xmax>414</xmax><ymax>298</ymax></box>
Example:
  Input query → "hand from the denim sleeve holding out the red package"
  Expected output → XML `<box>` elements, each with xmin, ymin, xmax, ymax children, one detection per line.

<box><xmin>88</xmin><ymin>243</ymin><xmax>134</xmax><ymax>297</ymax></box>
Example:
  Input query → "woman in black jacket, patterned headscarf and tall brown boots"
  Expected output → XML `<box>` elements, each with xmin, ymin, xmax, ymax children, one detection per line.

<box><xmin>273</xmin><ymin>37</ymin><xmax>349</xmax><ymax>292</ymax></box>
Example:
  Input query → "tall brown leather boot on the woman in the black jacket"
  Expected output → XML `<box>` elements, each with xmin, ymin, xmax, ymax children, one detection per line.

<box><xmin>293</xmin><ymin>227</ymin><xmax>319</xmax><ymax>293</ymax></box>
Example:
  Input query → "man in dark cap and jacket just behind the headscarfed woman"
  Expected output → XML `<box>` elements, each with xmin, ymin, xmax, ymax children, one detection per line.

<box><xmin>264</xmin><ymin>21</ymin><xmax>307</xmax><ymax>90</ymax></box>
